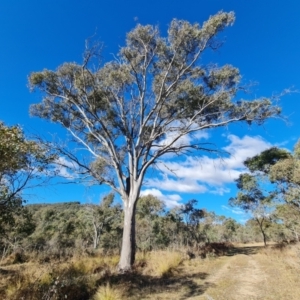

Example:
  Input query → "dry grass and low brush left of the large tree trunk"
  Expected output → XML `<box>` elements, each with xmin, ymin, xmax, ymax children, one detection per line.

<box><xmin>0</xmin><ymin>256</ymin><xmax>119</xmax><ymax>300</ymax></box>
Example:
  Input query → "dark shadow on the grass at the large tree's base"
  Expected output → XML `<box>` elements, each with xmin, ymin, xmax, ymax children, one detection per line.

<box><xmin>99</xmin><ymin>270</ymin><xmax>213</xmax><ymax>300</ymax></box>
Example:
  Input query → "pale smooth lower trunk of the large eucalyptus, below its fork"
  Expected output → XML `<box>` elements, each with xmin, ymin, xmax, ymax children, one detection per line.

<box><xmin>118</xmin><ymin>200</ymin><xmax>136</xmax><ymax>273</ymax></box>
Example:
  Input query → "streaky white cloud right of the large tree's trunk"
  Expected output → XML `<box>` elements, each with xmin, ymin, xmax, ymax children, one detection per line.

<box><xmin>147</xmin><ymin>135</ymin><xmax>272</xmax><ymax>195</ymax></box>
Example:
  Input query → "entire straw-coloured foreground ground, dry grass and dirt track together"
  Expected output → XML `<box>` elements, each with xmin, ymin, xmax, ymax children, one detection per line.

<box><xmin>0</xmin><ymin>245</ymin><xmax>300</xmax><ymax>300</ymax></box>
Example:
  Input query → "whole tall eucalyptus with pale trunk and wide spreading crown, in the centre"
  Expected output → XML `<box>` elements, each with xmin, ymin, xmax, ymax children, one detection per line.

<box><xmin>29</xmin><ymin>12</ymin><xmax>280</xmax><ymax>271</ymax></box>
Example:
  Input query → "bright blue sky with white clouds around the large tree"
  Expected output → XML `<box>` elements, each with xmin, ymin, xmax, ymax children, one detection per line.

<box><xmin>0</xmin><ymin>0</ymin><xmax>300</xmax><ymax>219</ymax></box>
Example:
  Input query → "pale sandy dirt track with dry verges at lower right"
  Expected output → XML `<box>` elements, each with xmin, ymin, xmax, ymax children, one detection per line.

<box><xmin>187</xmin><ymin>246</ymin><xmax>300</xmax><ymax>300</ymax></box>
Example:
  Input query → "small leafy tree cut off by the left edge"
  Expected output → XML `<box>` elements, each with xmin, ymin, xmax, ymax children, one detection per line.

<box><xmin>0</xmin><ymin>122</ymin><xmax>55</xmax><ymax>234</ymax></box>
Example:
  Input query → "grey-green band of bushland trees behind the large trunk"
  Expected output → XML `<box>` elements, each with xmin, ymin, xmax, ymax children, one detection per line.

<box><xmin>0</xmin><ymin>194</ymin><xmax>300</xmax><ymax>256</ymax></box>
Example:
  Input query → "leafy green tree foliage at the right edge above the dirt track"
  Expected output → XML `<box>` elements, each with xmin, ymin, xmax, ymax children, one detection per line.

<box><xmin>230</xmin><ymin>142</ymin><xmax>300</xmax><ymax>245</ymax></box>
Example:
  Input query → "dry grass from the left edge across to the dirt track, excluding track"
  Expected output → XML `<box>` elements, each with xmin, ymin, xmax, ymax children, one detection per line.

<box><xmin>0</xmin><ymin>247</ymin><xmax>226</xmax><ymax>300</ymax></box>
